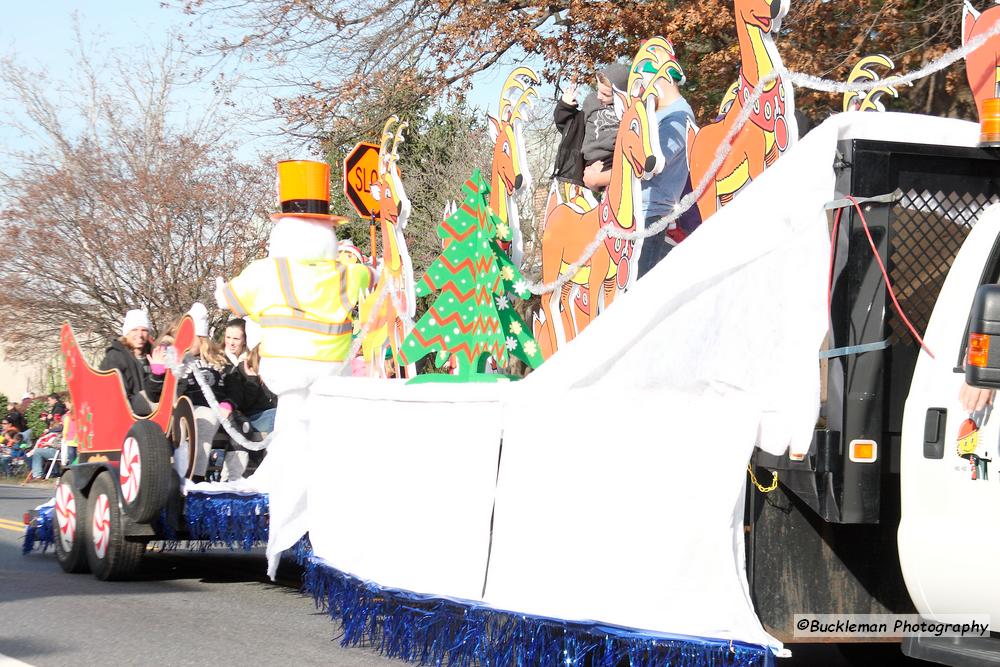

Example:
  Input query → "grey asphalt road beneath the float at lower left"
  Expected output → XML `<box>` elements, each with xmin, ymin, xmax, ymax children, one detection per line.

<box><xmin>0</xmin><ymin>484</ymin><xmax>404</xmax><ymax>667</ymax></box>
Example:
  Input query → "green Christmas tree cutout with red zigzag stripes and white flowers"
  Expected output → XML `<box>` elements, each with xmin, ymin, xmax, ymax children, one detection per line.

<box><xmin>400</xmin><ymin>169</ymin><xmax>542</xmax><ymax>382</ymax></box>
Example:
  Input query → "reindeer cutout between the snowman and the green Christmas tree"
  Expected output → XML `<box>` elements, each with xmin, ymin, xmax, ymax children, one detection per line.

<box><xmin>360</xmin><ymin>116</ymin><xmax>417</xmax><ymax>377</ymax></box>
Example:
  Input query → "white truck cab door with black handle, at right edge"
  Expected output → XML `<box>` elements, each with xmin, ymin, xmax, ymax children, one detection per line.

<box><xmin>898</xmin><ymin>204</ymin><xmax>1000</xmax><ymax>632</ymax></box>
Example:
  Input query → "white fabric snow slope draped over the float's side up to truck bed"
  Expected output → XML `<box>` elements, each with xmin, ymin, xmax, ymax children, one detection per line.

<box><xmin>215</xmin><ymin>113</ymin><xmax>978</xmax><ymax>650</ymax></box>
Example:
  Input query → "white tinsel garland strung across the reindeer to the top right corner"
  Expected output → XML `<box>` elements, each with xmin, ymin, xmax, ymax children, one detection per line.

<box><xmin>527</xmin><ymin>18</ymin><xmax>1000</xmax><ymax>294</ymax></box>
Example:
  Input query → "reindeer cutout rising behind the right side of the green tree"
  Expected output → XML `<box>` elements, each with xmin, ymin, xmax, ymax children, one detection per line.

<box><xmin>488</xmin><ymin>67</ymin><xmax>539</xmax><ymax>266</ymax></box>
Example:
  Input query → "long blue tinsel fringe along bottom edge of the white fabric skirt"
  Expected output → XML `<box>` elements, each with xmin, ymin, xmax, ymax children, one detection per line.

<box><xmin>305</xmin><ymin>559</ymin><xmax>774</xmax><ymax>667</ymax></box>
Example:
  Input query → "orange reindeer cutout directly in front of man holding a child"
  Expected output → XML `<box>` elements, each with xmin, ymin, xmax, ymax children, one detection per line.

<box><xmin>535</xmin><ymin>37</ymin><xmax>670</xmax><ymax>358</ymax></box>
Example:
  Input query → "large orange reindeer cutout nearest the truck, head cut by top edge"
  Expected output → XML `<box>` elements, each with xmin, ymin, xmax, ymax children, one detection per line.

<box><xmin>688</xmin><ymin>0</ymin><xmax>798</xmax><ymax>220</ymax></box>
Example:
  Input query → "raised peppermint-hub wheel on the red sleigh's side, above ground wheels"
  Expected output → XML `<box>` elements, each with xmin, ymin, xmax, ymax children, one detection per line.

<box><xmin>118</xmin><ymin>421</ymin><xmax>173</xmax><ymax>523</ymax></box>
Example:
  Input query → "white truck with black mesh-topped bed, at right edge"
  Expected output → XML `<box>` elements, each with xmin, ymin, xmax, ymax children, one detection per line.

<box><xmin>746</xmin><ymin>139</ymin><xmax>1000</xmax><ymax>665</ymax></box>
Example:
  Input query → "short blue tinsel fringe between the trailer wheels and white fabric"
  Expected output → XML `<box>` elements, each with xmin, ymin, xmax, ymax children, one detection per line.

<box><xmin>184</xmin><ymin>493</ymin><xmax>268</xmax><ymax>550</ymax></box>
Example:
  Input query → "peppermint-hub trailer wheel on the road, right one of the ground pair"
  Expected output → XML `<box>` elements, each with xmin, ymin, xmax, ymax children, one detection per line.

<box><xmin>86</xmin><ymin>471</ymin><xmax>146</xmax><ymax>581</ymax></box>
